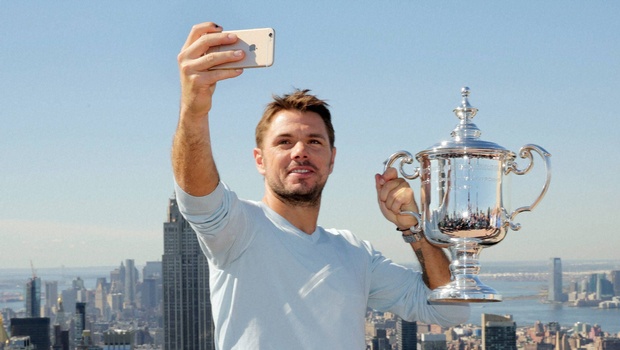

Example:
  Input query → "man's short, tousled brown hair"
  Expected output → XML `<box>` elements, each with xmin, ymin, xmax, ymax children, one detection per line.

<box><xmin>256</xmin><ymin>89</ymin><xmax>336</xmax><ymax>148</ymax></box>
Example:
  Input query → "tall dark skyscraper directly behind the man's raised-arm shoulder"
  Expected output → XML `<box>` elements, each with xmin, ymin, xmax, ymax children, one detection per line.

<box><xmin>162</xmin><ymin>198</ymin><xmax>215</xmax><ymax>350</ymax></box>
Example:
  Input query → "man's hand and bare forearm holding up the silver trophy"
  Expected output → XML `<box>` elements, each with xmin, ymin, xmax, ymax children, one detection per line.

<box><xmin>375</xmin><ymin>168</ymin><xmax>451</xmax><ymax>289</ymax></box>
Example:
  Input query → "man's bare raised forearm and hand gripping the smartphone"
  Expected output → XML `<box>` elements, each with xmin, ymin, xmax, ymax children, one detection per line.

<box><xmin>172</xmin><ymin>22</ymin><xmax>244</xmax><ymax>196</ymax></box>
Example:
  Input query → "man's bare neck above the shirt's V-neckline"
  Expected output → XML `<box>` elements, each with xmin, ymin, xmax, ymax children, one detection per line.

<box><xmin>263</xmin><ymin>192</ymin><xmax>321</xmax><ymax>235</ymax></box>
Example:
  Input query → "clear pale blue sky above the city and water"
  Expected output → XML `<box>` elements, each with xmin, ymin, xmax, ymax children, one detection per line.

<box><xmin>0</xmin><ymin>0</ymin><xmax>620</xmax><ymax>267</ymax></box>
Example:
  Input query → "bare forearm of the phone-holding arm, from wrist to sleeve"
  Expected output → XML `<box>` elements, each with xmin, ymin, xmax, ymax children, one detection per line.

<box><xmin>172</xmin><ymin>115</ymin><xmax>219</xmax><ymax>197</ymax></box>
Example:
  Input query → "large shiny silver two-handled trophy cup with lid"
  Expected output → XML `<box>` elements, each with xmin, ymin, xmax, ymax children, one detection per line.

<box><xmin>385</xmin><ymin>87</ymin><xmax>551</xmax><ymax>302</ymax></box>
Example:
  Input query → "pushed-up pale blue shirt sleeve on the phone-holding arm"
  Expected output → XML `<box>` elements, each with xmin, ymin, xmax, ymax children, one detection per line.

<box><xmin>175</xmin><ymin>182</ymin><xmax>250</xmax><ymax>267</ymax></box>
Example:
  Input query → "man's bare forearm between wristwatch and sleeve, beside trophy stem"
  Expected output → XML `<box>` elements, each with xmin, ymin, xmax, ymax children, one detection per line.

<box><xmin>411</xmin><ymin>238</ymin><xmax>451</xmax><ymax>289</ymax></box>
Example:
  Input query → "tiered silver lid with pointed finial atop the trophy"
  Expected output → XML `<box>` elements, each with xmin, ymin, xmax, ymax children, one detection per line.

<box><xmin>416</xmin><ymin>87</ymin><xmax>513</xmax><ymax>157</ymax></box>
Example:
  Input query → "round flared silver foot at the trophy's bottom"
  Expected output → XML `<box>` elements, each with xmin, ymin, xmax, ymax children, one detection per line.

<box><xmin>428</xmin><ymin>275</ymin><xmax>502</xmax><ymax>303</ymax></box>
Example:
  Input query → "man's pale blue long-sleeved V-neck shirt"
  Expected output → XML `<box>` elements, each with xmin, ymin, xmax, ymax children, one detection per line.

<box><xmin>176</xmin><ymin>183</ymin><xmax>469</xmax><ymax>350</ymax></box>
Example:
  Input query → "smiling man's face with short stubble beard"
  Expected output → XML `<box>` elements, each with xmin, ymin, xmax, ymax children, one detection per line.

<box><xmin>254</xmin><ymin>110</ymin><xmax>336</xmax><ymax>205</ymax></box>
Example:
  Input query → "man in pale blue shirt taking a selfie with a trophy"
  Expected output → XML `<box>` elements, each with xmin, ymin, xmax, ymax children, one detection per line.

<box><xmin>172</xmin><ymin>23</ymin><xmax>469</xmax><ymax>349</ymax></box>
